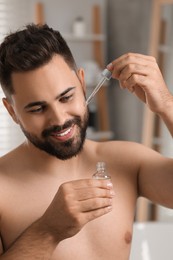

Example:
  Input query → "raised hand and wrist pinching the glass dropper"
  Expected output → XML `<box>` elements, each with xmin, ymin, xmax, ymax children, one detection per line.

<box><xmin>107</xmin><ymin>53</ymin><xmax>173</xmax><ymax>115</ymax></box>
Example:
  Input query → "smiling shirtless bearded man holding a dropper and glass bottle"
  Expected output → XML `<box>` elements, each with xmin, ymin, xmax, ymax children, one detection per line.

<box><xmin>0</xmin><ymin>25</ymin><xmax>173</xmax><ymax>260</ymax></box>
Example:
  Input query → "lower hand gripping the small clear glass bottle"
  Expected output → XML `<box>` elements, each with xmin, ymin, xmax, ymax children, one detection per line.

<box><xmin>42</xmin><ymin>179</ymin><xmax>114</xmax><ymax>242</ymax></box>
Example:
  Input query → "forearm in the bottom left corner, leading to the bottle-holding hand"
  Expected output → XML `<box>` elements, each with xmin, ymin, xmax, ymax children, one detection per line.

<box><xmin>0</xmin><ymin>220</ymin><xmax>58</xmax><ymax>260</ymax></box>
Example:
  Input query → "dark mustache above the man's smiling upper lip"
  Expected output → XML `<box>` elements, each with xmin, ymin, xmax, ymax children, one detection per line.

<box><xmin>42</xmin><ymin>117</ymin><xmax>81</xmax><ymax>138</ymax></box>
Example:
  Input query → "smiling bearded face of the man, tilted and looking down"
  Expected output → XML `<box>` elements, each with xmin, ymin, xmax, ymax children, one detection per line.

<box><xmin>8</xmin><ymin>55</ymin><xmax>88</xmax><ymax>160</ymax></box>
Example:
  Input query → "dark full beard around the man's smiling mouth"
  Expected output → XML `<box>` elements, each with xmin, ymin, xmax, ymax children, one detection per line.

<box><xmin>20</xmin><ymin>110</ymin><xmax>89</xmax><ymax>160</ymax></box>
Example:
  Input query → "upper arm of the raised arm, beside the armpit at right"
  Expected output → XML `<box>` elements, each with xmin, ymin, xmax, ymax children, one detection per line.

<box><xmin>138</xmin><ymin>144</ymin><xmax>173</xmax><ymax>208</ymax></box>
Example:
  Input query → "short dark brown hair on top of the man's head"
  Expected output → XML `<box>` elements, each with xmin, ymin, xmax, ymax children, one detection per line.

<box><xmin>0</xmin><ymin>24</ymin><xmax>76</xmax><ymax>95</ymax></box>
